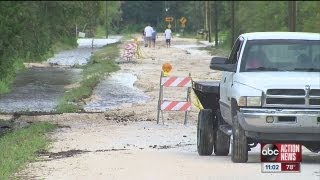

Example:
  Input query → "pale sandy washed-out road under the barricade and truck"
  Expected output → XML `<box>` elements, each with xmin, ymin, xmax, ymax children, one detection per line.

<box><xmin>16</xmin><ymin>36</ymin><xmax>320</xmax><ymax>180</ymax></box>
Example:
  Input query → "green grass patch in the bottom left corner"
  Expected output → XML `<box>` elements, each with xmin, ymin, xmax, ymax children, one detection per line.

<box><xmin>0</xmin><ymin>123</ymin><xmax>56</xmax><ymax>180</ymax></box>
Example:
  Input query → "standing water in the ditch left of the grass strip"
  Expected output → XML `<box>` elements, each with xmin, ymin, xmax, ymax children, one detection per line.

<box><xmin>0</xmin><ymin>36</ymin><xmax>121</xmax><ymax>113</ymax></box>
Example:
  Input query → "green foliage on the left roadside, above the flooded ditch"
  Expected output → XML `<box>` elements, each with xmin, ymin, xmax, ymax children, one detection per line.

<box><xmin>0</xmin><ymin>1</ymin><xmax>120</xmax><ymax>93</ymax></box>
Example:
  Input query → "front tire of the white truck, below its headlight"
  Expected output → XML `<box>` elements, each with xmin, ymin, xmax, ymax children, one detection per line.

<box><xmin>231</xmin><ymin>113</ymin><xmax>248</xmax><ymax>163</ymax></box>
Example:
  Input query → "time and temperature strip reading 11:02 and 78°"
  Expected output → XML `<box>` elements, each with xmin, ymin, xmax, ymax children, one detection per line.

<box><xmin>261</xmin><ymin>163</ymin><xmax>300</xmax><ymax>173</ymax></box>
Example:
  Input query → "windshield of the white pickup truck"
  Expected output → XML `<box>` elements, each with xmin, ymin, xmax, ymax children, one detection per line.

<box><xmin>240</xmin><ymin>40</ymin><xmax>320</xmax><ymax>72</ymax></box>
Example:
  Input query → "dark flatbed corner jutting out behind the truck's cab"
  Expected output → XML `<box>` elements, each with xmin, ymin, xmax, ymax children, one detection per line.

<box><xmin>192</xmin><ymin>81</ymin><xmax>220</xmax><ymax>111</ymax></box>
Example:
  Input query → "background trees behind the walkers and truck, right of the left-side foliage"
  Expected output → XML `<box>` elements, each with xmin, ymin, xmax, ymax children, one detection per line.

<box><xmin>121</xmin><ymin>1</ymin><xmax>320</xmax><ymax>43</ymax></box>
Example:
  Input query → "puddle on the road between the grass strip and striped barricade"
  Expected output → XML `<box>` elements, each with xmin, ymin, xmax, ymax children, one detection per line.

<box><xmin>84</xmin><ymin>73</ymin><xmax>148</xmax><ymax>111</ymax></box>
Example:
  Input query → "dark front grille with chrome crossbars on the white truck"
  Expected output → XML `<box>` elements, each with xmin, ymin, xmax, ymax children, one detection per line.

<box><xmin>265</xmin><ymin>89</ymin><xmax>320</xmax><ymax>108</ymax></box>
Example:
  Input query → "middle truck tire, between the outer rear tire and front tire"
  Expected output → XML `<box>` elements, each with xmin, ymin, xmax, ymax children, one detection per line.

<box><xmin>213</xmin><ymin>111</ymin><xmax>230</xmax><ymax>156</ymax></box>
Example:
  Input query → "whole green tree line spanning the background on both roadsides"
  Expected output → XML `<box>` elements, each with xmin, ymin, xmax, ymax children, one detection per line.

<box><xmin>0</xmin><ymin>1</ymin><xmax>320</xmax><ymax>92</ymax></box>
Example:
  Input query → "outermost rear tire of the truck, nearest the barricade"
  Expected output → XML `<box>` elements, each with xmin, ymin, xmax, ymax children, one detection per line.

<box><xmin>197</xmin><ymin>109</ymin><xmax>214</xmax><ymax>156</ymax></box>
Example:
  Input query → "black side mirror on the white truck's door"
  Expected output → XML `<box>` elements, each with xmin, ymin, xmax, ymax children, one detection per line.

<box><xmin>210</xmin><ymin>56</ymin><xmax>237</xmax><ymax>72</ymax></box>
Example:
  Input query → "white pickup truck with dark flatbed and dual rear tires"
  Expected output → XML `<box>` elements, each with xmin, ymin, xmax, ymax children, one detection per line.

<box><xmin>193</xmin><ymin>32</ymin><xmax>320</xmax><ymax>163</ymax></box>
